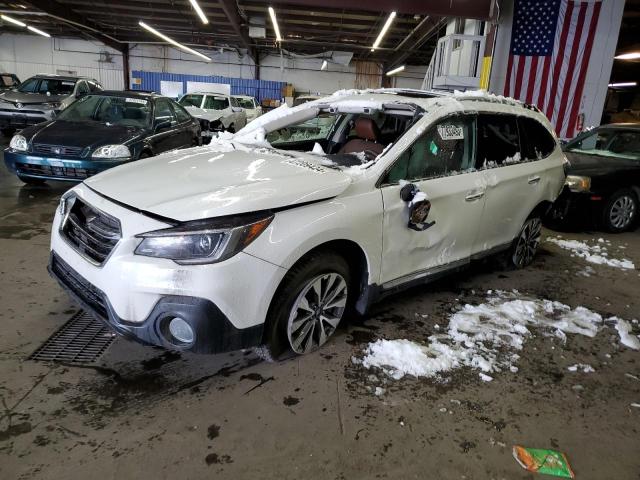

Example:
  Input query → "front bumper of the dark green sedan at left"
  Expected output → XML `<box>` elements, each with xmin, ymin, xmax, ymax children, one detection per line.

<box><xmin>4</xmin><ymin>148</ymin><xmax>123</xmax><ymax>182</ymax></box>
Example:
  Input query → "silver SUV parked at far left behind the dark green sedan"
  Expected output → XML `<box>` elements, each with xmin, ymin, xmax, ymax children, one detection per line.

<box><xmin>0</xmin><ymin>75</ymin><xmax>102</xmax><ymax>136</ymax></box>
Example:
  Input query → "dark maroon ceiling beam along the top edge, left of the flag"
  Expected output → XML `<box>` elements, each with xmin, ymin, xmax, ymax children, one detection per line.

<box><xmin>262</xmin><ymin>0</ymin><xmax>493</xmax><ymax>20</ymax></box>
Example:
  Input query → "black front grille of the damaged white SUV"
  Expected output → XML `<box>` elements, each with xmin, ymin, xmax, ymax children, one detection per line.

<box><xmin>62</xmin><ymin>197</ymin><xmax>122</xmax><ymax>265</ymax></box>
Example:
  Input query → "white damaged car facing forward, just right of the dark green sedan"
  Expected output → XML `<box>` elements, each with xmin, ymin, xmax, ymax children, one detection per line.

<box><xmin>178</xmin><ymin>92</ymin><xmax>247</xmax><ymax>141</ymax></box>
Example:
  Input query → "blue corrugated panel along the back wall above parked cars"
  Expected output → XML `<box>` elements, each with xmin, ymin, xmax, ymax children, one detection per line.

<box><xmin>131</xmin><ymin>70</ymin><xmax>286</xmax><ymax>102</ymax></box>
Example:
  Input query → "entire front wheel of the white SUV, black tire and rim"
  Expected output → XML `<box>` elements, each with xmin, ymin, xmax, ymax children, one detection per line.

<box><xmin>257</xmin><ymin>251</ymin><xmax>352</xmax><ymax>360</ymax></box>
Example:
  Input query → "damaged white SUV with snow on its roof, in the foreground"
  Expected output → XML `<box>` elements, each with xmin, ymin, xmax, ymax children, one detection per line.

<box><xmin>49</xmin><ymin>90</ymin><xmax>565</xmax><ymax>357</ymax></box>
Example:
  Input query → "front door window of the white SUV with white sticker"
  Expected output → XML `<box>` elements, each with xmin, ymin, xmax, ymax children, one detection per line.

<box><xmin>383</xmin><ymin>116</ymin><xmax>475</xmax><ymax>184</ymax></box>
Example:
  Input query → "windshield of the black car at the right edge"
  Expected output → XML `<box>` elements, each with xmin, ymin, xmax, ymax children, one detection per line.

<box><xmin>565</xmin><ymin>128</ymin><xmax>640</xmax><ymax>160</ymax></box>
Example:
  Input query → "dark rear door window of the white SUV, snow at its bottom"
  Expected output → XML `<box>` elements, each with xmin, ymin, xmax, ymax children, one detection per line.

<box><xmin>476</xmin><ymin>114</ymin><xmax>520</xmax><ymax>168</ymax></box>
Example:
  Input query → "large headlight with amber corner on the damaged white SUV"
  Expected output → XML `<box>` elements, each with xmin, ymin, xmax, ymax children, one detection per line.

<box><xmin>135</xmin><ymin>212</ymin><xmax>273</xmax><ymax>265</ymax></box>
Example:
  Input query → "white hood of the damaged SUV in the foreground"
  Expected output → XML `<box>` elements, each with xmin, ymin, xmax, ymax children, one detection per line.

<box><xmin>84</xmin><ymin>142</ymin><xmax>352</xmax><ymax>221</ymax></box>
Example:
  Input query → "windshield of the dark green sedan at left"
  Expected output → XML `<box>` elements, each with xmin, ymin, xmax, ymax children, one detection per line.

<box><xmin>58</xmin><ymin>95</ymin><xmax>150</xmax><ymax>127</ymax></box>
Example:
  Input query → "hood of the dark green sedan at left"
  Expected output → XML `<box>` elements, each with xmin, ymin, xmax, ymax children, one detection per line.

<box><xmin>22</xmin><ymin>120</ymin><xmax>145</xmax><ymax>149</ymax></box>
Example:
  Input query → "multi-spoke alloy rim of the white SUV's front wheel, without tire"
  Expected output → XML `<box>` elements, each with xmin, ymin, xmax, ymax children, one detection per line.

<box><xmin>287</xmin><ymin>273</ymin><xmax>348</xmax><ymax>354</ymax></box>
